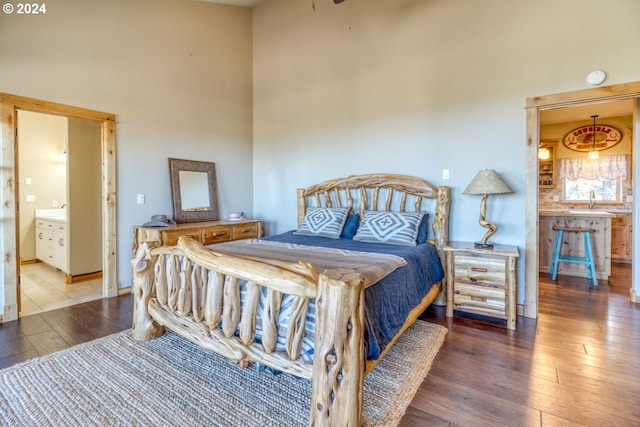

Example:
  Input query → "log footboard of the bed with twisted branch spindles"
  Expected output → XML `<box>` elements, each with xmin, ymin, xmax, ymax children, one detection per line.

<box><xmin>132</xmin><ymin>236</ymin><xmax>365</xmax><ymax>426</ymax></box>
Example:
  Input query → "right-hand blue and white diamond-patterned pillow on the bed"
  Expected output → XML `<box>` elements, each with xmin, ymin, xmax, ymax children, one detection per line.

<box><xmin>353</xmin><ymin>211</ymin><xmax>425</xmax><ymax>246</ymax></box>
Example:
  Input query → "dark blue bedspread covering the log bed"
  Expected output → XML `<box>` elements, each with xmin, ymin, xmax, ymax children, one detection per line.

<box><xmin>209</xmin><ymin>231</ymin><xmax>444</xmax><ymax>362</ymax></box>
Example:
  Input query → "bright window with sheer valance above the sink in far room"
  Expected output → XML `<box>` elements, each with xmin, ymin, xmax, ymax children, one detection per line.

<box><xmin>559</xmin><ymin>155</ymin><xmax>627</xmax><ymax>203</ymax></box>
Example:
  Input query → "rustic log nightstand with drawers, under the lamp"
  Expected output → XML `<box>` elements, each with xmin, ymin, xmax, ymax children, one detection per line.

<box><xmin>444</xmin><ymin>242</ymin><xmax>519</xmax><ymax>329</ymax></box>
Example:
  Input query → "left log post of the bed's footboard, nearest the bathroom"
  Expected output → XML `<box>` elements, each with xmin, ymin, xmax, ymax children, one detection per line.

<box><xmin>131</xmin><ymin>243</ymin><xmax>164</xmax><ymax>341</ymax></box>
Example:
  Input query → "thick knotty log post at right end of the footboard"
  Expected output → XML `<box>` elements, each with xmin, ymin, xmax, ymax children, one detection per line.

<box><xmin>309</xmin><ymin>274</ymin><xmax>365</xmax><ymax>427</ymax></box>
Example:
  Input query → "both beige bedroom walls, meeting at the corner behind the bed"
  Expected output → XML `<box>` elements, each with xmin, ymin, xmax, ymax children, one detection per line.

<box><xmin>0</xmin><ymin>0</ymin><xmax>640</xmax><ymax>302</ymax></box>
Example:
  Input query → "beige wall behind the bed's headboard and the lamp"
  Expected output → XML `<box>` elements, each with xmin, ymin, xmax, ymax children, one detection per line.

<box><xmin>253</xmin><ymin>0</ymin><xmax>640</xmax><ymax>304</ymax></box>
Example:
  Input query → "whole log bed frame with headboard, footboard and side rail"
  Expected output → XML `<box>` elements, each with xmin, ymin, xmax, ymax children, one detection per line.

<box><xmin>132</xmin><ymin>174</ymin><xmax>451</xmax><ymax>426</ymax></box>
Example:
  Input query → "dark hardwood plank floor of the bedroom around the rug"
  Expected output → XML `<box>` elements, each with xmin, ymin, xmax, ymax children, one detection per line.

<box><xmin>0</xmin><ymin>264</ymin><xmax>640</xmax><ymax>427</ymax></box>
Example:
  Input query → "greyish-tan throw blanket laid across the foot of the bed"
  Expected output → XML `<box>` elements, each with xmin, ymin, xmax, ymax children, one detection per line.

<box><xmin>209</xmin><ymin>239</ymin><xmax>407</xmax><ymax>289</ymax></box>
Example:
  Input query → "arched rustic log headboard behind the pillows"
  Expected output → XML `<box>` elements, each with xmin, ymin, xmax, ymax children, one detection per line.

<box><xmin>298</xmin><ymin>174</ymin><xmax>451</xmax><ymax>256</ymax></box>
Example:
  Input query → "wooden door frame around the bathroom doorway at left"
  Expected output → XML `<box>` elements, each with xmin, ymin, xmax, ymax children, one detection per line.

<box><xmin>0</xmin><ymin>93</ymin><xmax>118</xmax><ymax>321</ymax></box>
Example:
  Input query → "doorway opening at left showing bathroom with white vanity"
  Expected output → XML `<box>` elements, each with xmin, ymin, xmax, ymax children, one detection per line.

<box><xmin>16</xmin><ymin>110</ymin><xmax>103</xmax><ymax>317</ymax></box>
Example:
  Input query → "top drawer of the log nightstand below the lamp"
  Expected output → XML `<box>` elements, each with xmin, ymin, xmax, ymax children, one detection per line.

<box><xmin>454</xmin><ymin>253</ymin><xmax>506</xmax><ymax>288</ymax></box>
